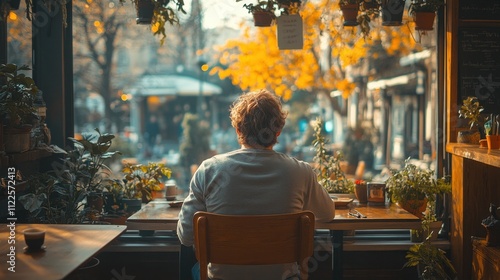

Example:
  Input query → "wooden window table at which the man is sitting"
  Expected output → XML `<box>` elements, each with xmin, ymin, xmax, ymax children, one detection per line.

<box><xmin>126</xmin><ymin>200</ymin><xmax>421</xmax><ymax>279</ymax></box>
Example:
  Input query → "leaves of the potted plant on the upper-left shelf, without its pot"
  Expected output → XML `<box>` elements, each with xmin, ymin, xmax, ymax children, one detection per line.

<box><xmin>0</xmin><ymin>64</ymin><xmax>38</xmax><ymax>127</ymax></box>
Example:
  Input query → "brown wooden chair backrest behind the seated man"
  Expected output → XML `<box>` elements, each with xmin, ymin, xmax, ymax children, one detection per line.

<box><xmin>193</xmin><ymin>211</ymin><xmax>314</xmax><ymax>279</ymax></box>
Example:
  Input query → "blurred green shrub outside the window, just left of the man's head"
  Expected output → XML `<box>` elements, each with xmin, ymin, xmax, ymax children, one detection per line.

<box><xmin>180</xmin><ymin>113</ymin><xmax>210</xmax><ymax>168</ymax></box>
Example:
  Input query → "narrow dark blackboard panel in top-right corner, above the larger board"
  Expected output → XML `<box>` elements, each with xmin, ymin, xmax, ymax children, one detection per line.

<box><xmin>458</xmin><ymin>0</ymin><xmax>500</xmax><ymax>20</ymax></box>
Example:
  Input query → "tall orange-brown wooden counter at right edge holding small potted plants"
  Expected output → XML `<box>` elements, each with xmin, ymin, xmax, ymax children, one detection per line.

<box><xmin>446</xmin><ymin>143</ymin><xmax>500</xmax><ymax>279</ymax></box>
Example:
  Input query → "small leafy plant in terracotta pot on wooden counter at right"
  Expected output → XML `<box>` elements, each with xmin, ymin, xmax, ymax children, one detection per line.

<box><xmin>457</xmin><ymin>96</ymin><xmax>486</xmax><ymax>144</ymax></box>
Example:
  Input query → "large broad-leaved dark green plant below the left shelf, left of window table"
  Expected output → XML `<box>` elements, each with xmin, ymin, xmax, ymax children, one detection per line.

<box><xmin>19</xmin><ymin>129</ymin><xmax>119</xmax><ymax>224</ymax></box>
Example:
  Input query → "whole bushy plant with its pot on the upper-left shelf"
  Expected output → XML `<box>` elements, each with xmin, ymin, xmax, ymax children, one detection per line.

<box><xmin>0</xmin><ymin>64</ymin><xmax>38</xmax><ymax>153</ymax></box>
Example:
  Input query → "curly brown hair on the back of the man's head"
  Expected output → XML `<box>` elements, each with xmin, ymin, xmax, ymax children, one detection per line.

<box><xmin>230</xmin><ymin>89</ymin><xmax>287</xmax><ymax>148</ymax></box>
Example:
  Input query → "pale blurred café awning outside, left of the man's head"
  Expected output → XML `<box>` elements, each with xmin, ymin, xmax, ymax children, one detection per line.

<box><xmin>131</xmin><ymin>74</ymin><xmax>222</xmax><ymax>96</ymax></box>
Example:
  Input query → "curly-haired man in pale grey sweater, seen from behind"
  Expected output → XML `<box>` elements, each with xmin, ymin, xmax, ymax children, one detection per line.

<box><xmin>177</xmin><ymin>90</ymin><xmax>335</xmax><ymax>280</ymax></box>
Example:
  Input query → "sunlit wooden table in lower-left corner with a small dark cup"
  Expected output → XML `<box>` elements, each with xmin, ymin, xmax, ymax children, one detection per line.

<box><xmin>0</xmin><ymin>224</ymin><xmax>127</xmax><ymax>280</ymax></box>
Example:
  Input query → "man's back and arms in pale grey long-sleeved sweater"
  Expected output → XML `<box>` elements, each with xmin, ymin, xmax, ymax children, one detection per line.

<box><xmin>178</xmin><ymin>149</ymin><xmax>334</xmax><ymax>279</ymax></box>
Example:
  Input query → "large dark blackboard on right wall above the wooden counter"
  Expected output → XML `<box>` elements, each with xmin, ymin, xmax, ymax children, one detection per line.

<box><xmin>458</xmin><ymin>27</ymin><xmax>500</xmax><ymax>114</ymax></box>
